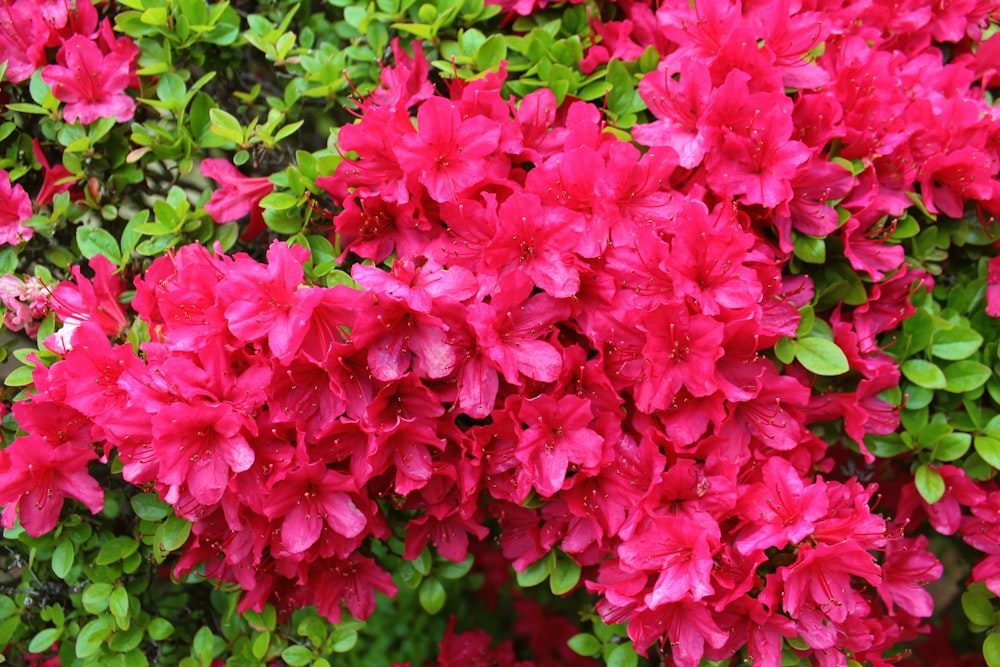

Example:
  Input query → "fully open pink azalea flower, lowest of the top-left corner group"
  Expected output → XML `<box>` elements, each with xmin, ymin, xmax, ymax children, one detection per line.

<box><xmin>42</xmin><ymin>35</ymin><xmax>135</xmax><ymax>124</ymax></box>
